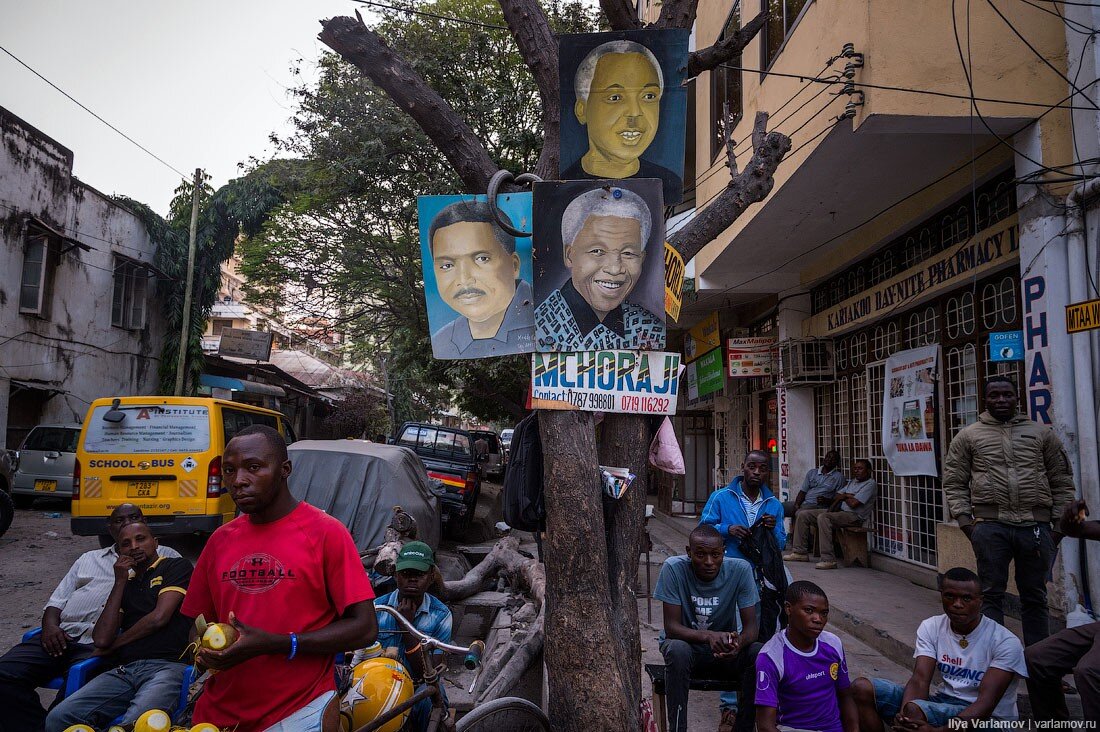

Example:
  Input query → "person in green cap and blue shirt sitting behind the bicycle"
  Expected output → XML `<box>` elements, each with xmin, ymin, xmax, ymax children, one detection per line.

<box><xmin>374</xmin><ymin>542</ymin><xmax>451</xmax><ymax>731</ymax></box>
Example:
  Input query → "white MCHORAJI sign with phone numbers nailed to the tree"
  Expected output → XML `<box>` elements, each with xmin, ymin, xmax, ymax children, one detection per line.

<box><xmin>531</xmin><ymin>351</ymin><xmax>680</xmax><ymax>415</ymax></box>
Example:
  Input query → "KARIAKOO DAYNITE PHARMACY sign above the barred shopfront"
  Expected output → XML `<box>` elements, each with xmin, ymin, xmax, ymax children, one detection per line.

<box><xmin>802</xmin><ymin>214</ymin><xmax>1020</xmax><ymax>336</ymax></box>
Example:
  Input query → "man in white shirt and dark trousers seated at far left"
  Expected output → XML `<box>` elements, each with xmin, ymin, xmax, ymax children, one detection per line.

<box><xmin>0</xmin><ymin>503</ymin><xmax>179</xmax><ymax>732</ymax></box>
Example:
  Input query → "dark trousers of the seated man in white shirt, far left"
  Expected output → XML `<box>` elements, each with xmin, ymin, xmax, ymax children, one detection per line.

<box><xmin>0</xmin><ymin>638</ymin><xmax>95</xmax><ymax>732</ymax></box>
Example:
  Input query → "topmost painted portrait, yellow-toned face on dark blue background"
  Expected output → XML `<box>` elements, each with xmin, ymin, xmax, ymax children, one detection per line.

<box><xmin>558</xmin><ymin>29</ymin><xmax>690</xmax><ymax>205</ymax></box>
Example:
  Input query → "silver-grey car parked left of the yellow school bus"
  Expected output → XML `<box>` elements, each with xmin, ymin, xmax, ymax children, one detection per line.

<box><xmin>11</xmin><ymin>424</ymin><xmax>80</xmax><ymax>509</ymax></box>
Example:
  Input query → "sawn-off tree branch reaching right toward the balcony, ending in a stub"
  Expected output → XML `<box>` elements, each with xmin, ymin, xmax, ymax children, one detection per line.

<box><xmin>669</xmin><ymin>112</ymin><xmax>791</xmax><ymax>262</ymax></box>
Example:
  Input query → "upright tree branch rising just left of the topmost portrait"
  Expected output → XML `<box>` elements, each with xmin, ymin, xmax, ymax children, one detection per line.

<box><xmin>499</xmin><ymin>0</ymin><xmax>561</xmax><ymax>179</ymax></box>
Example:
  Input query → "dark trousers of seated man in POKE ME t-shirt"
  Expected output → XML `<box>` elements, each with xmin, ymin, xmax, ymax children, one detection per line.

<box><xmin>661</xmin><ymin>641</ymin><xmax>762</xmax><ymax>732</ymax></box>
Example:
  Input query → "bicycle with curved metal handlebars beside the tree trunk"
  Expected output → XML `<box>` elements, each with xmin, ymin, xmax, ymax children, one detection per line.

<box><xmin>354</xmin><ymin>605</ymin><xmax>550</xmax><ymax>732</ymax></box>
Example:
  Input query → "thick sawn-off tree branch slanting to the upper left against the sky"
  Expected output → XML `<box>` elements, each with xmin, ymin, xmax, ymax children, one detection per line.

<box><xmin>318</xmin><ymin>12</ymin><xmax>496</xmax><ymax>193</ymax></box>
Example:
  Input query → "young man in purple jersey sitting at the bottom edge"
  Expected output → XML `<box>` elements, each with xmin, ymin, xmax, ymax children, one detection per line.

<box><xmin>756</xmin><ymin>581</ymin><xmax>859</xmax><ymax>732</ymax></box>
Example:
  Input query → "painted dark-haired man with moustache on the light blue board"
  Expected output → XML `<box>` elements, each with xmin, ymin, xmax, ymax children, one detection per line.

<box><xmin>425</xmin><ymin>200</ymin><xmax>534</xmax><ymax>359</ymax></box>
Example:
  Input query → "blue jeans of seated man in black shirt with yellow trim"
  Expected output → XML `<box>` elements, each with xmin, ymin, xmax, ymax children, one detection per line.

<box><xmin>46</xmin><ymin>660</ymin><xmax>187</xmax><ymax>732</ymax></box>
